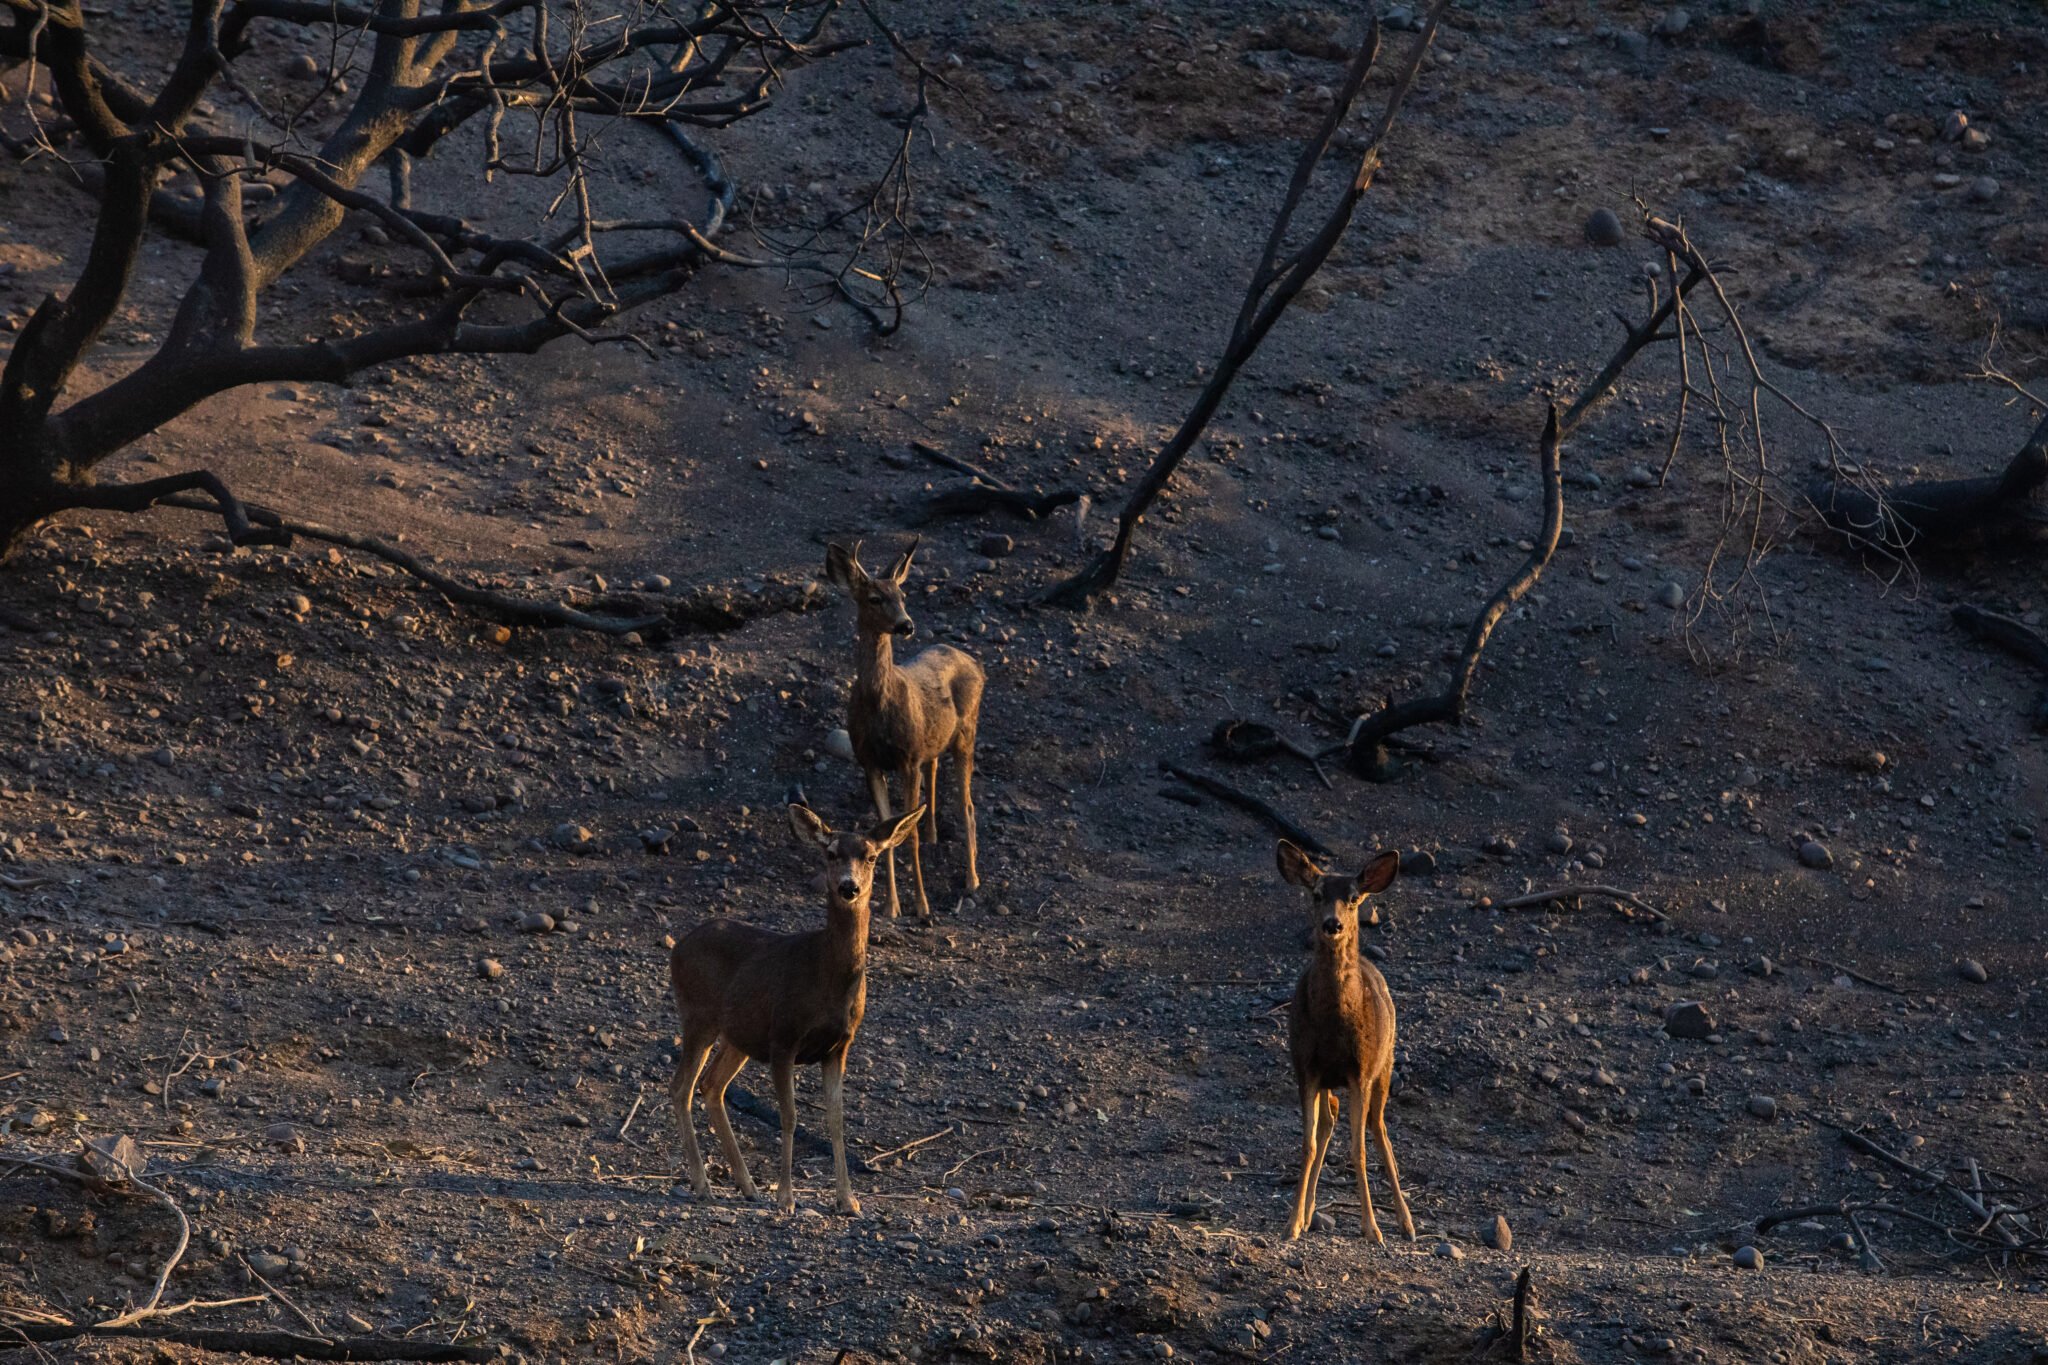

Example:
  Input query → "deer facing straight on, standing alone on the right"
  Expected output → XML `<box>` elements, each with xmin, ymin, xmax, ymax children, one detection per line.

<box><xmin>1276</xmin><ymin>839</ymin><xmax>1415</xmax><ymax>1242</ymax></box>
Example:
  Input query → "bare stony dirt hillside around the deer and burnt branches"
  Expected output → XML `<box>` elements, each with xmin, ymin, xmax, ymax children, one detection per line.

<box><xmin>0</xmin><ymin>0</ymin><xmax>2048</xmax><ymax>1365</ymax></box>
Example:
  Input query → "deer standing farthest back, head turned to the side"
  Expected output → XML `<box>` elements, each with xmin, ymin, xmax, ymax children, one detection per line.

<box><xmin>825</xmin><ymin>540</ymin><xmax>987</xmax><ymax>917</ymax></box>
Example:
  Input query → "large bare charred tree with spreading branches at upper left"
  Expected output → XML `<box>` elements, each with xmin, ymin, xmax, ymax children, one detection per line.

<box><xmin>0</xmin><ymin>0</ymin><xmax>926</xmax><ymax>634</ymax></box>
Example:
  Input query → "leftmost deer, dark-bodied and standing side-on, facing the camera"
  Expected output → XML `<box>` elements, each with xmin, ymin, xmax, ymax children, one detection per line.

<box><xmin>668</xmin><ymin>804</ymin><xmax>924</xmax><ymax>1214</ymax></box>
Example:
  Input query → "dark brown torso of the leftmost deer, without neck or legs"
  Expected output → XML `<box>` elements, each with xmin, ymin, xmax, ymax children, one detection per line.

<box><xmin>670</xmin><ymin>919</ymin><xmax>868</xmax><ymax>1064</ymax></box>
